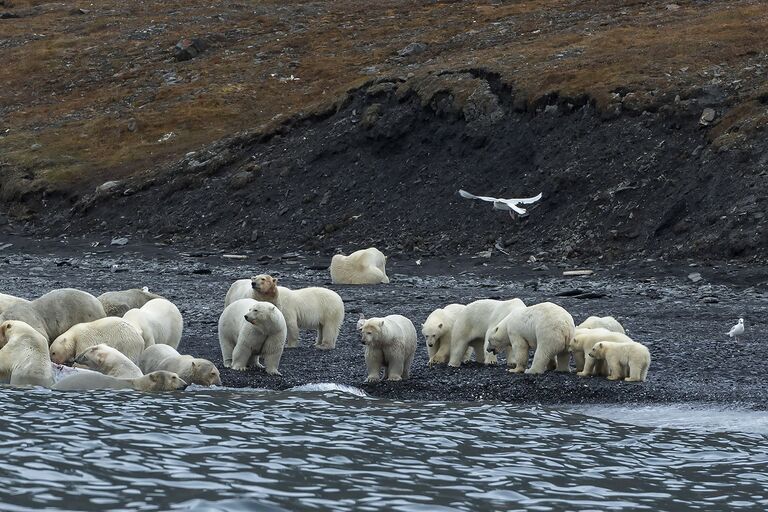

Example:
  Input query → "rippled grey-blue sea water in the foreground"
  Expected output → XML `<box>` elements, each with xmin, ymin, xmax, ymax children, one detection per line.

<box><xmin>0</xmin><ymin>386</ymin><xmax>768</xmax><ymax>511</ymax></box>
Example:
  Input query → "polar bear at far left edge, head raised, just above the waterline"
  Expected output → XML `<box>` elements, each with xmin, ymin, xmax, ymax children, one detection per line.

<box><xmin>0</xmin><ymin>320</ymin><xmax>53</xmax><ymax>388</ymax></box>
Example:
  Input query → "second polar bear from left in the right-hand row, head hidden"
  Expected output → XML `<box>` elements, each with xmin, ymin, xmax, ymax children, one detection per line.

<box><xmin>448</xmin><ymin>299</ymin><xmax>525</xmax><ymax>367</ymax></box>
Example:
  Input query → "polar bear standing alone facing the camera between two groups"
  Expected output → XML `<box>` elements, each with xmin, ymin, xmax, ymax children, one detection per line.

<box><xmin>360</xmin><ymin>315</ymin><xmax>416</xmax><ymax>382</ymax></box>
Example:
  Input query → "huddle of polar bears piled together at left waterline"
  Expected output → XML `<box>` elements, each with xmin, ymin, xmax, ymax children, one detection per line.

<box><xmin>0</xmin><ymin>288</ymin><xmax>221</xmax><ymax>391</ymax></box>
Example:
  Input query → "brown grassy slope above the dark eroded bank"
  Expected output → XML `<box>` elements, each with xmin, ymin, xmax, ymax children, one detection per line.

<box><xmin>0</xmin><ymin>0</ymin><xmax>768</xmax><ymax>192</ymax></box>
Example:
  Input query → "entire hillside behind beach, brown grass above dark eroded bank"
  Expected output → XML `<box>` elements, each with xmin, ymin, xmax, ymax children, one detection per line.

<box><xmin>0</xmin><ymin>0</ymin><xmax>768</xmax><ymax>259</ymax></box>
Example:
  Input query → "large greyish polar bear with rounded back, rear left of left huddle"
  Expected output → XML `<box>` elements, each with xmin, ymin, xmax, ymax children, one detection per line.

<box><xmin>0</xmin><ymin>288</ymin><xmax>106</xmax><ymax>343</ymax></box>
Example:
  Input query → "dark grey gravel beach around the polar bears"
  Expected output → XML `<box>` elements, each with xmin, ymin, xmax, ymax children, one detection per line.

<box><xmin>0</xmin><ymin>237</ymin><xmax>768</xmax><ymax>409</ymax></box>
